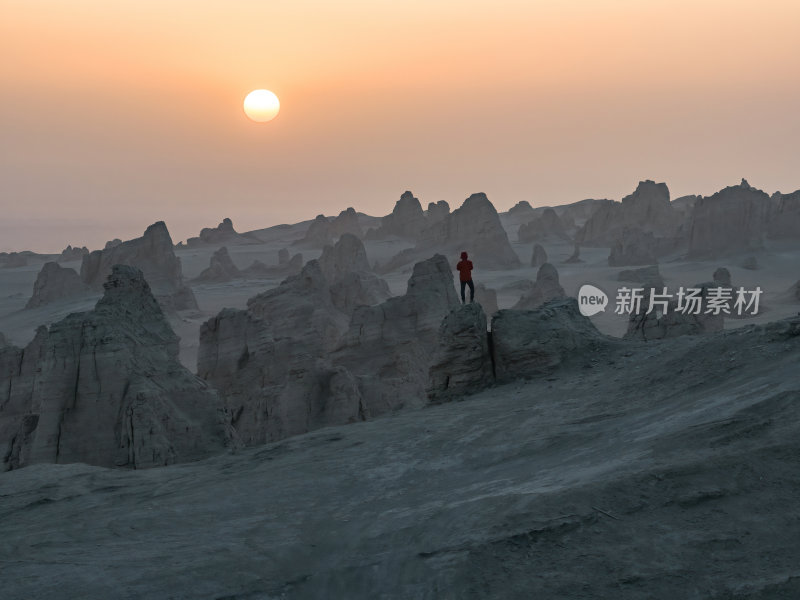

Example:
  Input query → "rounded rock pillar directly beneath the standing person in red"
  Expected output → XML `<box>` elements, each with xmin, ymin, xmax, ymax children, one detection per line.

<box><xmin>427</xmin><ymin>304</ymin><xmax>494</xmax><ymax>402</ymax></box>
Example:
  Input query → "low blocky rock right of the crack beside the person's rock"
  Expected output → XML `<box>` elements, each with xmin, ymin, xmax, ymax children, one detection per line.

<box><xmin>492</xmin><ymin>298</ymin><xmax>613</xmax><ymax>383</ymax></box>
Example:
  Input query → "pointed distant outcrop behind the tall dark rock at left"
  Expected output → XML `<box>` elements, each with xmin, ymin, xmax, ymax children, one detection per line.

<box><xmin>81</xmin><ymin>221</ymin><xmax>197</xmax><ymax>310</ymax></box>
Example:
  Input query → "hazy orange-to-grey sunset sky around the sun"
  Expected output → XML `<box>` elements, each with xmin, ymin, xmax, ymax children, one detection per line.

<box><xmin>0</xmin><ymin>0</ymin><xmax>800</xmax><ymax>252</ymax></box>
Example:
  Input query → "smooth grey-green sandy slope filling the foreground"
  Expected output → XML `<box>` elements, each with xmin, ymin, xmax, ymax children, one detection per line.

<box><xmin>0</xmin><ymin>319</ymin><xmax>800</xmax><ymax>599</ymax></box>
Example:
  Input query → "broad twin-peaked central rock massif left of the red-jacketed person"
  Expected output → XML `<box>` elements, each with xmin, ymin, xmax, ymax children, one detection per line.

<box><xmin>198</xmin><ymin>253</ymin><xmax>458</xmax><ymax>444</ymax></box>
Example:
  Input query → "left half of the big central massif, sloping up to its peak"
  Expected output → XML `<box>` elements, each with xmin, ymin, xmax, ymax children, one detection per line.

<box><xmin>197</xmin><ymin>260</ymin><xmax>350</xmax><ymax>445</ymax></box>
